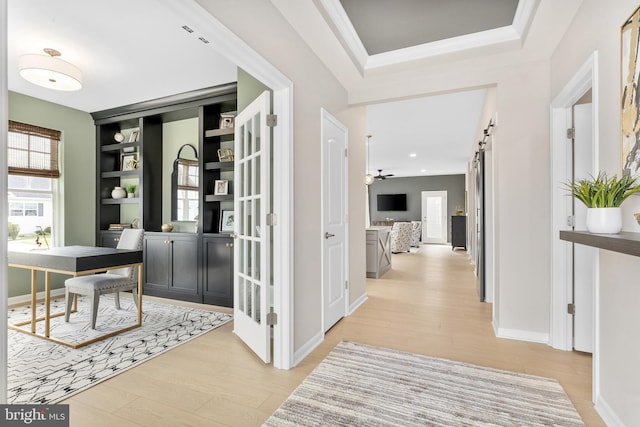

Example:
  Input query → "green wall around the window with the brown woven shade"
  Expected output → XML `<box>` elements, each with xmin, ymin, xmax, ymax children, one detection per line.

<box><xmin>3</xmin><ymin>91</ymin><xmax>96</xmax><ymax>297</ymax></box>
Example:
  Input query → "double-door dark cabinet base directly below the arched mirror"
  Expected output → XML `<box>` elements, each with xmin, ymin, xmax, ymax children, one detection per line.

<box><xmin>144</xmin><ymin>233</ymin><xmax>201</xmax><ymax>302</ymax></box>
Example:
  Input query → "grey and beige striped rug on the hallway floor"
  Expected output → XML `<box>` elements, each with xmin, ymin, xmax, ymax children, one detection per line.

<box><xmin>264</xmin><ymin>342</ymin><xmax>584</xmax><ymax>427</ymax></box>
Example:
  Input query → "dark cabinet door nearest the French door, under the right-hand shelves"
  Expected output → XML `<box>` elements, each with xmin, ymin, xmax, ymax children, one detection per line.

<box><xmin>202</xmin><ymin>237</ymin><xmax>233</xmax><ymax>307</ymax></box>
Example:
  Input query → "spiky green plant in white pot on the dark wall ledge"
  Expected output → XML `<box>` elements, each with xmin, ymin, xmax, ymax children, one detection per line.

<box><xmin>565</xmin><ymin>172</ymin><xmax>640</xmax><ymax>234</ymax></box>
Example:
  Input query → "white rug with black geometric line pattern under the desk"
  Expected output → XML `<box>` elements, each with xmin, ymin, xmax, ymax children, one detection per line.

<box><xmin>7</xmin><ymin>294</ymin><xmax>232</xmax><ymax>404</ymax></box>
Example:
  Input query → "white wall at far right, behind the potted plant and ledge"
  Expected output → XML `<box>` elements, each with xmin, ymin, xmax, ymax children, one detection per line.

<box><xmin>551</xmin><ymin>0</ymin><xmax>640</xmax><ymax>426</ymax></box>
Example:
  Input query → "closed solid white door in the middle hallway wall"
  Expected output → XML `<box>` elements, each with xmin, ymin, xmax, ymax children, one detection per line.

<box><xmin>322</xmin><ymin>110</ymin><xmax>348</xmax><ymax>332</ymax></box>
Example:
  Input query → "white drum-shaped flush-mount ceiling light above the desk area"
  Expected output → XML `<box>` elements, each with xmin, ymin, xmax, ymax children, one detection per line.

<box><xmin>18</xmin><ymin>48</ymin><xmax>82</xmax><ymax>91</ymax></box>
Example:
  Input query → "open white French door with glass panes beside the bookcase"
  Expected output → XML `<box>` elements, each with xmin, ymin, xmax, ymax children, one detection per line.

<box><xmin>233</xmin><ymin>91</ymin><xmax>271</xmax><ymax>363</ymax></box>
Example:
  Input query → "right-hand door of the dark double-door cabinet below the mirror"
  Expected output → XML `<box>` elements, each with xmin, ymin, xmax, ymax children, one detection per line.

<box><xmin>169</xmin><ymin>237</ymin><xmax>198</xmax><ymax>294</ymax></box>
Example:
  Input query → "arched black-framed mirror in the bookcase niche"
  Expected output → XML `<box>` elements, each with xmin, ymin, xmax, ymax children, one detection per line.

<box><xmin>171</xmin><ymin>144</ymin><xmax>200</xmax><ymax>221</ymax></box>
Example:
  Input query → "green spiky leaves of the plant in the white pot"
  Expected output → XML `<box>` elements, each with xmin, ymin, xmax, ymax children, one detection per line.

<box><xmin>565</xmin><ymin>172</ymin><xmax>640</xmax><ymax>208</ymax></box>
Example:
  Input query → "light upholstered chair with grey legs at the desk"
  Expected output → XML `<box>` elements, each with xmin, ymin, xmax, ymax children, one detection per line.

<box><xmin>64</xmin><ymin>228</ymin><xmax>144</xmax><ymax>329</ymax></box>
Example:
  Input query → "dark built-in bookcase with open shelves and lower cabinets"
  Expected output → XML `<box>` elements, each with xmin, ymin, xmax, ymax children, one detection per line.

<box><xmin>92</xmin><ymin>83</ymin><xmax>237</xmax><ymax>307</ymax></box>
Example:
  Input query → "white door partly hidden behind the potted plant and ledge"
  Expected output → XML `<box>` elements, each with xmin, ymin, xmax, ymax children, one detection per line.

<box><xmin>572</xmin><ymin>104</ymin><xmax>598</xmax><ymax>353</ymax></box>
